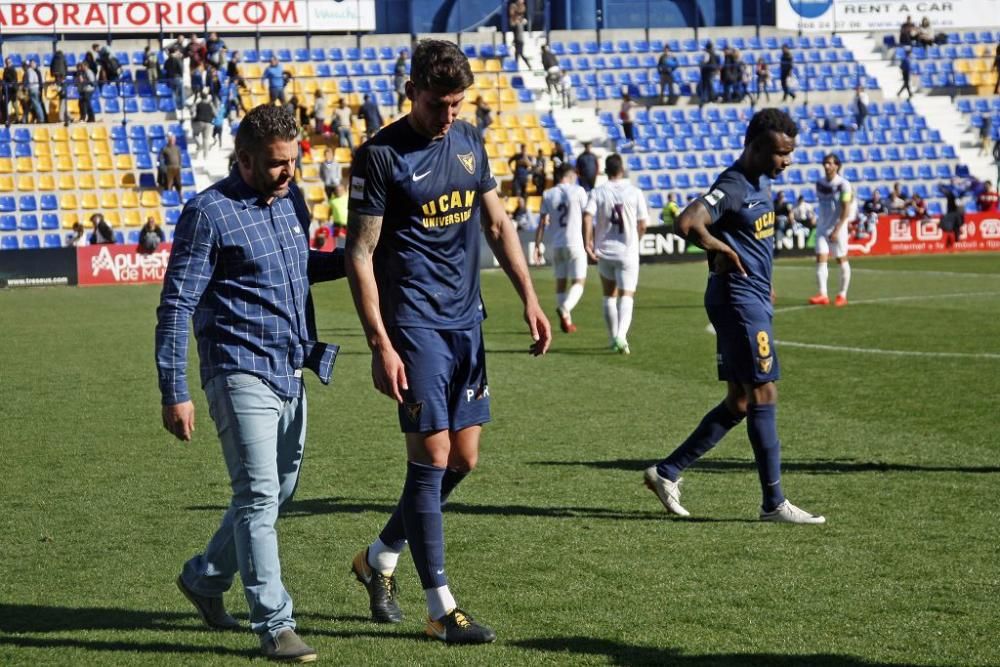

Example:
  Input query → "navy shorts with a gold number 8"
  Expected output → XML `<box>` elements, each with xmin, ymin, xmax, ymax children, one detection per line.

<box><xmin>705</xmin><ymin>276</ymin><xmax>781</xmax><ymax>384</ymax></box>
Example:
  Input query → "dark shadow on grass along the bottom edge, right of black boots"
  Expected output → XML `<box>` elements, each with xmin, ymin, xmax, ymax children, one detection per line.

<box><xmin>511</xmin><ymin>637</ymin><xmax>916</xmax><ymax>667</ymax></box>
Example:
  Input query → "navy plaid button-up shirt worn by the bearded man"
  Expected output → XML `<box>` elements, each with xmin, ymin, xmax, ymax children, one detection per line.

<box><xmin>156</xmin><ymin>169</ymin><xmax>344</xmax><ymax>405</ymax></box>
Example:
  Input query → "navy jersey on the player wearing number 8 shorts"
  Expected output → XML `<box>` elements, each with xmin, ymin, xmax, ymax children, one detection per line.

<box><xmin>698</xmin><ymin>164</ymin><xmax>774</xmax><ymax>299</ymax></box>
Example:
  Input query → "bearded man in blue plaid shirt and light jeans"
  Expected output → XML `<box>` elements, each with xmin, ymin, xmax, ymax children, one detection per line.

<box><xmin>156</xmin><ymin>105</ymin><xmax>344</xmax><ymax>662</ymax></box>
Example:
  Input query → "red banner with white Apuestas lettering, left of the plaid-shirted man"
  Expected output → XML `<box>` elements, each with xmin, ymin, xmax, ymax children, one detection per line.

<box><xmin>76</xmin><ymin>243</ymin><xmax>171</xmax><ymax>285</ymax></box>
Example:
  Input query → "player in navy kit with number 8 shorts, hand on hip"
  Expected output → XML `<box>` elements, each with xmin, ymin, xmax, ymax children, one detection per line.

<box><xmin>643</xmin><ymin>109</ymin><xmax>826</xmax><ymax>524</ymax></box>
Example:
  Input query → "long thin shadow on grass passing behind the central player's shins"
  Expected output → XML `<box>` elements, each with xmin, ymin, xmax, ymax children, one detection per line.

<box><xmin>193</xmin><ymin>498</ymin><xmax>688</xmax><ymax>521</ymax></box>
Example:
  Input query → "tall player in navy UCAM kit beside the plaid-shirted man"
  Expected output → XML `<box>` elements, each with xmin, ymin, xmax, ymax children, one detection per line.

<box><xmin>346</xmin><ymin>40</ymin><xmax>551</xmax><ymax>643</ymax></box>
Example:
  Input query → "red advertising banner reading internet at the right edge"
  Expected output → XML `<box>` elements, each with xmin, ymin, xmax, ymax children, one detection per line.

<box><xmin>847</xmin><ymin>211</ymin><xmax>1000</xmax><ymax>256</ymax></box>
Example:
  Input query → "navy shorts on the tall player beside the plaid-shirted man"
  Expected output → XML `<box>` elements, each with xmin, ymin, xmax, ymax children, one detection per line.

<box><xmin>389</xmin><ymin>325</ymin><xmax>490</xmax><ymax>433</ymax></box>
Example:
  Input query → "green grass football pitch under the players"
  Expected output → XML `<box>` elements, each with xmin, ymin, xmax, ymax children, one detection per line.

<box><xmin>0</xmin><ymin>255</ymin><xmax>1000</xmax><ymax>667</ymax></box>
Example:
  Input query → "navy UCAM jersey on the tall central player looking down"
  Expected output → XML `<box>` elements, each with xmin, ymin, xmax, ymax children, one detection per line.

<box><xmin>350</xmin><ymin>117</ymin><xmax>496</xmax><ymax>329</ymax></box>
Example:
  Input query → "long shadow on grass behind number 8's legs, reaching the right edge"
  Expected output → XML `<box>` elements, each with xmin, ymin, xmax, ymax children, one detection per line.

<box><xmin>533</xmin><ymin>459</ymin><xmax>1000</xmax><ymax>475</ymax></box>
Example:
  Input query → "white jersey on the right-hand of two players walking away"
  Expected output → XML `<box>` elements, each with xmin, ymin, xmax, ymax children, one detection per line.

<box><xmin>585</xmin><ymin>178</ymin><xmax>649</xmax><ymax>260</ymax></box>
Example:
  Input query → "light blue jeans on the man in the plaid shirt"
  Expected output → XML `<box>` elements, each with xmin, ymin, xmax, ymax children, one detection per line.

<box><xmin>181</xmin><ymin>373</ymin><xmax>306</xmax><ymax>637</ymax></box>
